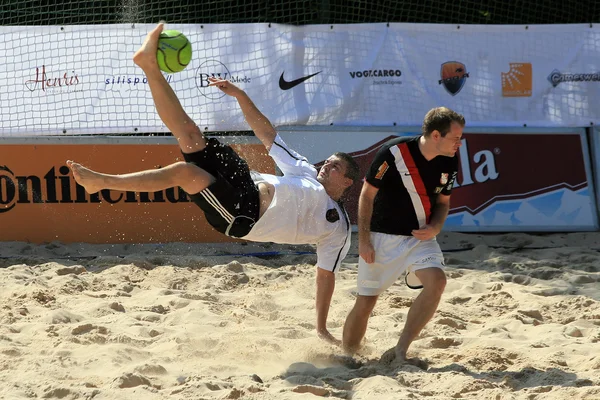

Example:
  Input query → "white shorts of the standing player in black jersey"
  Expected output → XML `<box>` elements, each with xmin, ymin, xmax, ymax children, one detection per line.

<box><xmin>358</xmin><ymin>232</ymin><xmax>444</xmax><ymax>296</ymax></box>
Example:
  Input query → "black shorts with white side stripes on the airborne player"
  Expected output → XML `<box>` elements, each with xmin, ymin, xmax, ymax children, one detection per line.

<box><xmin>182</xmin><ymin>138</ymin><xmax>260</xmax><ymax>238</ymax></box>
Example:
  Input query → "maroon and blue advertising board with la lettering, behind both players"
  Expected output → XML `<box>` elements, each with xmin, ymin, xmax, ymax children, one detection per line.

<box><xmin>280</xmin><ymin>128</ymin><xmax>598</xmax><ymax>232</ymax></box>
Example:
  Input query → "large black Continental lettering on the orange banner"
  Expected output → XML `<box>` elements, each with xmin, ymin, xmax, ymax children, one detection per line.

<box><xmin>0</xmin><ymin>165</ymin><xmax>189</xmax><ymax>214</ymax></box>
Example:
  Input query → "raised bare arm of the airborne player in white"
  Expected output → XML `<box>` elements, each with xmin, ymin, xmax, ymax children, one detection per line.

<box><xmin>208</xmin><ymin>78</ymin><xmax>277</xmax><ymax>151</ymax></box>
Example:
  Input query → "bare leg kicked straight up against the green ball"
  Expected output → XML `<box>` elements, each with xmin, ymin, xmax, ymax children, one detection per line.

<box><xmin>133</xmin><ymin>23</ymin><xmax>206</xmax><ymax>153</ymax></box>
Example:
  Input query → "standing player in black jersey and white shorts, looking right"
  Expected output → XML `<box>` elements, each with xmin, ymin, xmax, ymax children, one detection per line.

<box><xmin>343</xmin><ymin>107</ymin><xmax>465</xmax><ymax>361</ymax></box>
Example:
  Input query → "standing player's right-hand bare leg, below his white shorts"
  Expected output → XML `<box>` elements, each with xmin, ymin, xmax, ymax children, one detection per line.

<box><xmin>396</xmin><ymin>268</ymin><xmax>446</xmax><ymax>361</ymax></box>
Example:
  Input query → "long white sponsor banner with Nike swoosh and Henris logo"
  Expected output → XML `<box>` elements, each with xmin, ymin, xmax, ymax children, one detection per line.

<box><xmin>0</xmin><ymin>24</ymin><xmax>600</xmax><ymax>136</ymax></box>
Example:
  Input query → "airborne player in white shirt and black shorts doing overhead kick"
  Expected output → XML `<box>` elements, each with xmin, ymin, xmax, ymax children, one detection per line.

<box><xmin>67</xmin><ymin>23</ymin><xmax>359</xmax><ymax>343</ymax></box>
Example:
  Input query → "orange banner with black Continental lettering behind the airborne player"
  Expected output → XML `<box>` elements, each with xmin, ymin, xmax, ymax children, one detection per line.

<box><xmin>0</xmin><ymin>144</ymin><xmax>275</xmax><ymax>243</ymax></box>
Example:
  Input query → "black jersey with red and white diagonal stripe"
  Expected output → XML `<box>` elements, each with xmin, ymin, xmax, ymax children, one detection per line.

<box><xmin>365</xmin><ymin>136</ymin><xmax>458</xmax><ymax>236</ymax></box>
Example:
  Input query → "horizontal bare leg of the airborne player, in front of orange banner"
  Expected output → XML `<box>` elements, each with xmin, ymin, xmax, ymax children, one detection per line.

<box><xmin>67</xmin><ymin>161</ymin><xmax>214</xmax><ymax>194</ymax></box>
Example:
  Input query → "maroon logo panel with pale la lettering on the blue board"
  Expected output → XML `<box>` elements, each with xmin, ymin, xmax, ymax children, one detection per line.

<box><xmin>450</xmin><ymin>132</ymin><xmax>587</xmax><ymax>214</ymax></box>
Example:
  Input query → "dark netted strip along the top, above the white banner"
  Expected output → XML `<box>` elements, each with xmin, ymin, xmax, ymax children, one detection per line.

<box><xmin>0</xmin><ymin>0</ymin><xmax>600</xmax><ymax>25</ymax></box>
